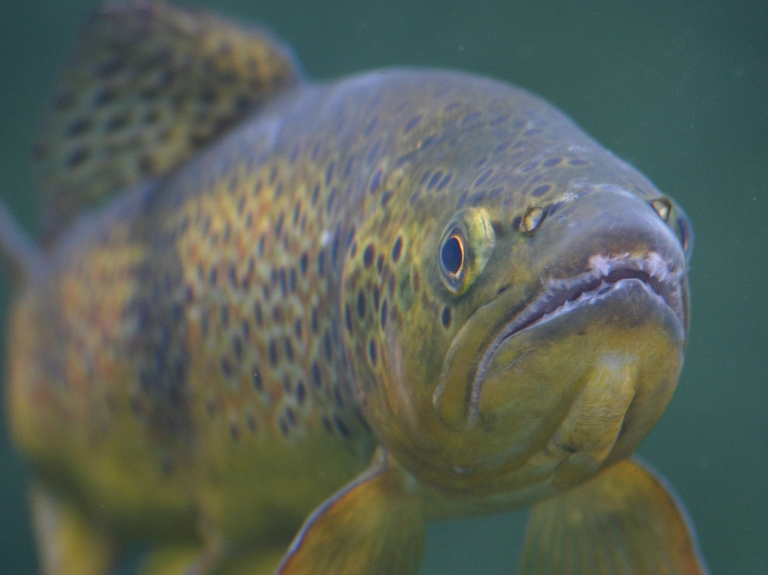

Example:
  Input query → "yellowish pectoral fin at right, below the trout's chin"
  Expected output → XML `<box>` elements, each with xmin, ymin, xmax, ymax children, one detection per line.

<box><xmin>519</xmin><ymin>460</ymin><xmax>707</xmax><ymax>575</ymax></box>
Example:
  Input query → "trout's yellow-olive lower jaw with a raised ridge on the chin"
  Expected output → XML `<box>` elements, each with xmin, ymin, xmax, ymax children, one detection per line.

<box><xmin>469</xmin><ymin>282</ymin><xmax>685</xmax><ymax>487</ymax></box>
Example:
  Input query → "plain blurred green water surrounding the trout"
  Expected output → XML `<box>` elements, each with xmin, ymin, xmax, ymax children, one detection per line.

<box><xmin>0</xmin><ymin>0</ymin><xmax>768</xmax><ymax>575</ymax></box>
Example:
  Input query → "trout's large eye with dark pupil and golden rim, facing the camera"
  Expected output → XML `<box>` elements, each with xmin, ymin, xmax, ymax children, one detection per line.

<box><xmin>438</xmin><ymin>208</ymin><xmax>496</xmax><ymax>296</ymax></box>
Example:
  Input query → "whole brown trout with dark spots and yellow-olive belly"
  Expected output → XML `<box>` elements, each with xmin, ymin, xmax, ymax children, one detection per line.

<box><xmin>0</xmin><ymin>1</ymin><xmax>706</xmax><ymax>575</ymax></box>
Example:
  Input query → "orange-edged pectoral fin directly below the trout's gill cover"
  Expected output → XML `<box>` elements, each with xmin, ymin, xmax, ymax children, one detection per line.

<box><xmin>277</xmin><ymin>452</ymin><xmax>424</xmax><ymax>575</ymax></box>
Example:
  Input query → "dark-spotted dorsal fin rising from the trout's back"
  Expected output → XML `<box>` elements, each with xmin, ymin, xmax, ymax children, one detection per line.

<box><xmin>34</xmin><ymin>0</ymin><xmax>299</xmax><ymax>242</ymax></box>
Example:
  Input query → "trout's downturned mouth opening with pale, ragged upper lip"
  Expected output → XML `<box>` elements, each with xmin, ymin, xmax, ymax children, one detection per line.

<box><xmin>471</xmin><ymin>253</ymin><xmax>687</xmax><ymax>411</ymax></box>
